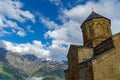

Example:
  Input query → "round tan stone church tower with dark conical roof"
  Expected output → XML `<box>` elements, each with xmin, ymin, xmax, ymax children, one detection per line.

<box><xmin>81</xmin><ymin>11</ymin><xmax>112</xmax><ymax>47</ymax></box>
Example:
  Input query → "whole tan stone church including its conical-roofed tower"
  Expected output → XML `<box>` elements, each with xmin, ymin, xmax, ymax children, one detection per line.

<box><xmin>65</xmin><ymin>11</ymin><xmax>120</xmax><ymax>80</ymax></box>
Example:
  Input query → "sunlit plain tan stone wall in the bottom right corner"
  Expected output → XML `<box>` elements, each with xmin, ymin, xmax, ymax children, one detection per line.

<box><xmin>92</xmin><ymin>35</ymin><xmax>120</xmax><ymax>80</ymax></box>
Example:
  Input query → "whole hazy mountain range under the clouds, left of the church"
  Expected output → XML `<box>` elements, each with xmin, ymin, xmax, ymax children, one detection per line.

<box><xmin>0</xmin><ymin>48</ymin><xmax>67</xmax><ymax>80</ymax></box>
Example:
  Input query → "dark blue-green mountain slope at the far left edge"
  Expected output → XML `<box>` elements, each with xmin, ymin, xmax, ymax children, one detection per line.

<box><xmin>0</xmin><ymin>48</ymin><xmax>27</xmax><ymax>80</ymax></box>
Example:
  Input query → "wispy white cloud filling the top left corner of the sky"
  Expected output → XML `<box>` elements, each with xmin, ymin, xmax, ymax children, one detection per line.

<box><xmin>0</xmin><ymin>0</ymin><xmax>35</xmax><ymax>22</ymax></box>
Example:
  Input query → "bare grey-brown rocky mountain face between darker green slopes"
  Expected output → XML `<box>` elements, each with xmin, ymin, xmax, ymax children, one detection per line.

<box><xmin>6</xmin><ymin>52</ymin><xmax>40</xmax><ymax>75</ymax></box>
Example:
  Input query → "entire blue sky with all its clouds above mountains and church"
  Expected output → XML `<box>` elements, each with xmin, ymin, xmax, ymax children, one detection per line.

<box><xmin>0</xmin><ymin>0</ymin><xmax>120</xmax><ymax>60</ymax></box>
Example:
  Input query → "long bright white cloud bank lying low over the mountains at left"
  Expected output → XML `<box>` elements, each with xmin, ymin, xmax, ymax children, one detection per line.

<box><xmin>0</xmin><ymin>40</ymin><xmax>50</xmax><ymax>58</ymax></box>
